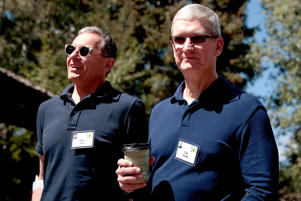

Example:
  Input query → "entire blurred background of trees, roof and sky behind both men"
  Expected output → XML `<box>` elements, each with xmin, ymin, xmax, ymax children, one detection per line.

<box><xmin>0</xmin><ymin>0</ymin><xmax>301</xmax><ymax>201</ymax></box>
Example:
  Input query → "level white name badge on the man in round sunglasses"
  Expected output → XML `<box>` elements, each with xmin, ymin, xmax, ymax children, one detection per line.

<box><xmin>71</xmin><ymin>131</ymin><xmax>95</xmax><ymax>149</ymax></box>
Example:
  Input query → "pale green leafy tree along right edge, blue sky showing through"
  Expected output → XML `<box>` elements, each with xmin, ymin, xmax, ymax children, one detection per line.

<box><xmin>246</xmin><ymin>0</ymin><xmax>301</xmax><ymax>200</ymax></box>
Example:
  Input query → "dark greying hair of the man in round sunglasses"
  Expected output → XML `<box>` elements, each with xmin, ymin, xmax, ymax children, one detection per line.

<box><xmin>77</xmin><ymin>26</ymin><xmax>117</xmax><ymax>59</ymax></box>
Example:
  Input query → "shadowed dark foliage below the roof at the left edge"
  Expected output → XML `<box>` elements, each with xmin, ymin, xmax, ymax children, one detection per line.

<box><xmin>0</xmin><ymin>124</ymin><xmax>38</xmax><ymax>201</ymax></box>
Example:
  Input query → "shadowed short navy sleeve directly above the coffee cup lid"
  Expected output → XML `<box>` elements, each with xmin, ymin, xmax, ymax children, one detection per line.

<box><xmin>125</xmin><ymin>99</ymin><xmax>148</xmax><ymax>143</ymax></box>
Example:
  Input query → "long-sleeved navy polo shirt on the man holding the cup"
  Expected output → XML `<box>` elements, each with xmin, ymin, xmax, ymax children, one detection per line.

<box><xmin>149</xmin><ymin>77</ymin><xmax>278</xmax><ymax>201</ymax></box>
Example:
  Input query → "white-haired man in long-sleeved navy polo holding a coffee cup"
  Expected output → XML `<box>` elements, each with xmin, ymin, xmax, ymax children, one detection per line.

<box><xmin>116</xmin><ymin>4</ymin><xmax>278</xmax><ymax>201</ymax></box>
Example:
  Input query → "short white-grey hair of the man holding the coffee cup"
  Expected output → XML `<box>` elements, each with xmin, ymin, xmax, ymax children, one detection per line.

<box><xmin>171</xmin><ymin>4</ymin><xmax>221</xmax><ymax>36</ymax></box>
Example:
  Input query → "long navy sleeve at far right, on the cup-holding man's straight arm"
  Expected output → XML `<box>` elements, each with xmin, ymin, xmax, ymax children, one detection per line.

<box><xmin>239</xmin><ymin>107</ymin><xmax>279</xmax><ymax>201</ymax></box>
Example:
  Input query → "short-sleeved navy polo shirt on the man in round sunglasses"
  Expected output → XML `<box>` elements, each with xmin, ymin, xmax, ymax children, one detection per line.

<box><xmin>36</xmin><ymin>82</ymin><xmax>148</xmax><ymax>201</ymax></box>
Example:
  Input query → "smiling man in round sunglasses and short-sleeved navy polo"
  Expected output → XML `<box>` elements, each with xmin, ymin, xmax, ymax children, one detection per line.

<box><xmin>32</xmin><ymin>27</ymin><xmax>148</xmax><ymax>201</ymax></box>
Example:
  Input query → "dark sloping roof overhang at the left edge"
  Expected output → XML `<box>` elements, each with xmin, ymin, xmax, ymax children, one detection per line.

<box><xmin>0</xmin><ymin>67</ymin><xmax>54</xmax><ymax>131</ymax></box>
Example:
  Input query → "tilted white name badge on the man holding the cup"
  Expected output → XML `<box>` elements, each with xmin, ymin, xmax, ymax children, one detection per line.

<box><xmin>176</xmin><ymin>140</ymin><xmax>199</xmax><ymax>165</ymax></box>
